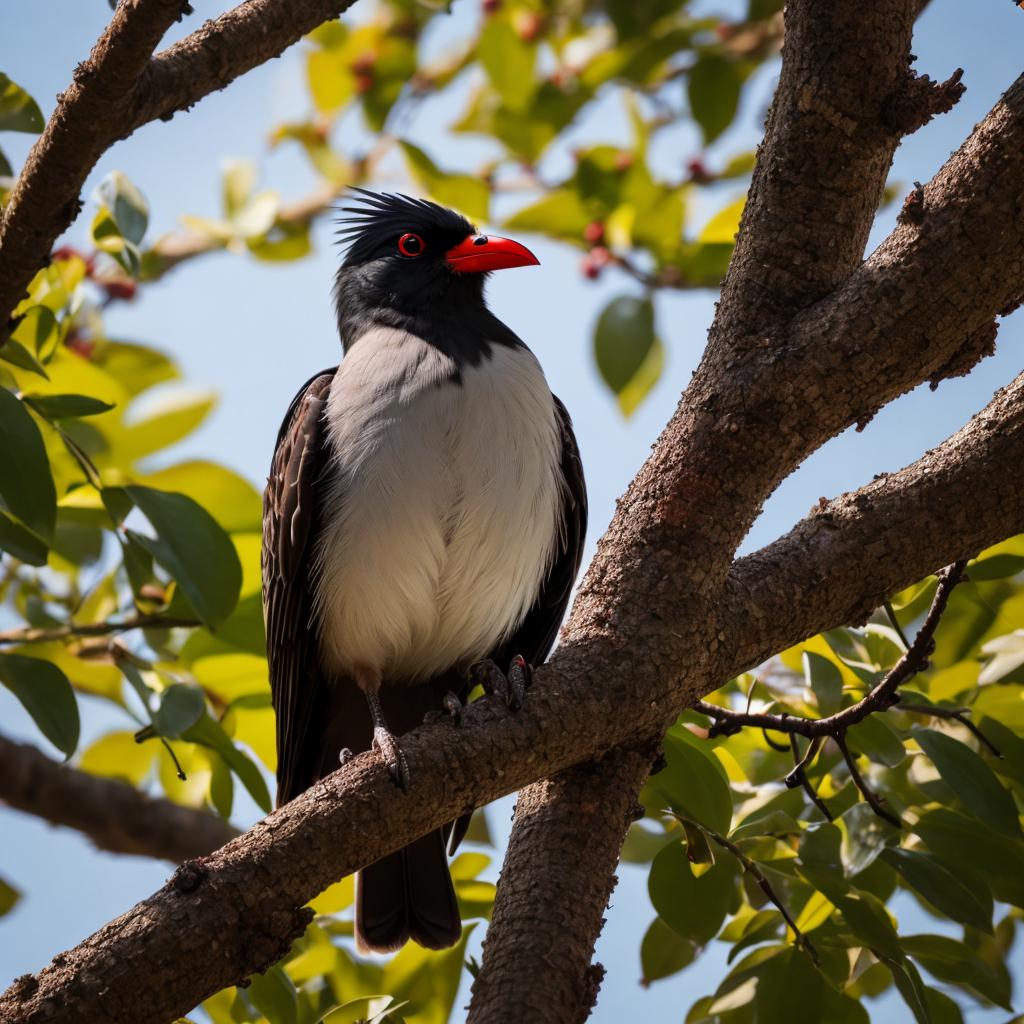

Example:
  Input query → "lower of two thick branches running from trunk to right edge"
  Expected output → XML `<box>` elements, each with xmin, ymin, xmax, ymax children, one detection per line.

<box><xmin>721</xmin><ymin>374</ymin><xmax>1024</xmax><ymax>675</ymax></box>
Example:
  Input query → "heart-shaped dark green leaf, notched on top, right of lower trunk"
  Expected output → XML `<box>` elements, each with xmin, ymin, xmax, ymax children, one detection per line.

<box><xmin>647</xmin><ymin>843</ymin><xmax>735</xmax><ymax>945</ymax></box>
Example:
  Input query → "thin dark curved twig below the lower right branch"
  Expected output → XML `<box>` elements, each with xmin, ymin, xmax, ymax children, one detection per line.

<box><xmin>693</xmin><ymin>559</ymin><xmax>967</xmax><ymax>739</ymax></box>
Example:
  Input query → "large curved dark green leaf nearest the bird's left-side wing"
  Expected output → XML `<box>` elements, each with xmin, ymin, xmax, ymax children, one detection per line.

<box><xmin>124</xmin><ymin>485</ymin><xmax>242</xmax><ymax>628</ymax></box>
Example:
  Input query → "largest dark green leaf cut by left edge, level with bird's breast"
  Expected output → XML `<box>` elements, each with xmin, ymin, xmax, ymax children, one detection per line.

<box><xmin>0</xmin><ymin>388</ymin><xmax>57</xmax><ymax>544</ymax></box>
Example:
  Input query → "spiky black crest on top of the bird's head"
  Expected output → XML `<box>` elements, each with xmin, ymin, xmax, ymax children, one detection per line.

<box><xmin>338</xmin><ymin>186</ymin><xmax>476</xmax><ymax>264</ymax></box>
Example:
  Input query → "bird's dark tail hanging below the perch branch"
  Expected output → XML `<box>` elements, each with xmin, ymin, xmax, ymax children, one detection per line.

<box><xmin>355</xmin><ymin>828</ymin><xmax>462</xmax><ymax>952</ymax></box>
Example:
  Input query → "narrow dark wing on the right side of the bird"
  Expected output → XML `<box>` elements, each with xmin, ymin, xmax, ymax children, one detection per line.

<box><xmin>493</xmin><ymin>398</ymin><xmax>587</xmax><ymax>671</ymax></box>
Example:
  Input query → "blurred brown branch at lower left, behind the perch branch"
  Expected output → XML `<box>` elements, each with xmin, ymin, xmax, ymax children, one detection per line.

<box><xmin>0</xmin><ymin>736</ymin><xmax>239</xmax><ymax>861</ymax></box>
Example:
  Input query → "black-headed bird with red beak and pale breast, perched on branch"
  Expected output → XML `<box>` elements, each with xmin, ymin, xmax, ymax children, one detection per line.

<box><xmin>262</xmin><ymin>188</ymin><xmax>587</xmax><ymax>952</ymax></box>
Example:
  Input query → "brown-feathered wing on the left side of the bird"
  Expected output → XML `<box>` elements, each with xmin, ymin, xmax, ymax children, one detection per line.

<box><xmin>263</xmin><ymin>370</ymin><xmax>334</xmax><ymax>805</ymax></box>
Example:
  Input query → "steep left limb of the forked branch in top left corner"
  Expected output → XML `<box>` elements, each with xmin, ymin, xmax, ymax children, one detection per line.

<box><xmin>0</xmin><ymin>0</ymin><xmax>184</xmax><ymax>324</ymax></box>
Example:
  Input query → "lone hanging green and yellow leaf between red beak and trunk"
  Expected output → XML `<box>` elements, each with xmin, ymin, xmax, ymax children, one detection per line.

<box><xmin>594</xmin><ymin>295</ymin><xmax>665</xmax><ymax>416</ymax></box>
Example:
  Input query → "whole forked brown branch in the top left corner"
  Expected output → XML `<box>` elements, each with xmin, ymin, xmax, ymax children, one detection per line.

<box><xmin>0</xmin><ymin>0</ymin><xmax>354</xmax><ymax>323</ymax></box>
